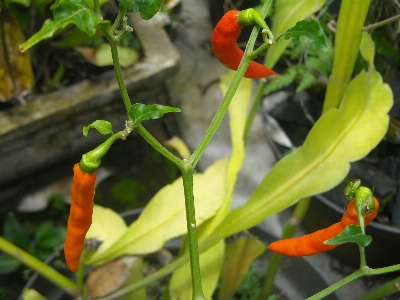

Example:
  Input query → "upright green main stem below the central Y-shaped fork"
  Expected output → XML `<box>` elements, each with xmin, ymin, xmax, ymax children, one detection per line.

<box><xmin>182</xmin><ymin>161</ymin><xmax>205</xmax><ymax>300</ymax></box>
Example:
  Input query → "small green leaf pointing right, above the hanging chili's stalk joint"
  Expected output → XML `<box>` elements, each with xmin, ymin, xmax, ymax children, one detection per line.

<box><xmin>129</xmin><ymin>103</ymin><xmax>181</xmax><ymax>126</ymax></box>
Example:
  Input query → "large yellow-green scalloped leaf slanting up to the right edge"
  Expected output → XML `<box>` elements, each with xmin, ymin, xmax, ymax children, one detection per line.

<box><xmin>215</xmin><ymin>71</ymin><xmax>393</xmax><ymax>236</ymax></box>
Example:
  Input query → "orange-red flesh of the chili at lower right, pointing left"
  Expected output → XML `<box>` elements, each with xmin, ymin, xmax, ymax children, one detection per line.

<box><xmin>268</xmin><ymin>197</ymin><xmax>379</xmax><ymax>256</ymax></box>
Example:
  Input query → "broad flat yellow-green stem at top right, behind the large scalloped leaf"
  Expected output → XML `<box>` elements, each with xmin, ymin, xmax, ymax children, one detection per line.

<box><xmin>322</xmin><ymin>0</ymin><xmax>371</xmax><ymax>113</ymax></box>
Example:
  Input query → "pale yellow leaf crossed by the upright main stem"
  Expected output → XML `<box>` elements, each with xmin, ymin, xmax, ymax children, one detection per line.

<box><xmin>91</xmin><ymin>158</ymin><xmax>228</xmax><ymax>263</ymax></box>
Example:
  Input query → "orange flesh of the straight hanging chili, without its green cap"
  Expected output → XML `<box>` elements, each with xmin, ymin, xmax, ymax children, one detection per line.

<box><xmin>64</xmin><ymin>164</ymin><xmax>96</xmax><ymax>272</ymax></box>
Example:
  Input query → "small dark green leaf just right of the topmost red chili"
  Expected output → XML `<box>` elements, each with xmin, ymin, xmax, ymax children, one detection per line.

<box><xmin>284</xmin><ymin>20</ymin><xmax>329</xmax><ymax>51</ymax></box>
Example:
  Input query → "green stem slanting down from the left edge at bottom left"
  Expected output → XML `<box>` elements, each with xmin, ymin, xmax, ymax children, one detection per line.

<box><xmin>0</xmin><ymin>236</ymin><xmax>78</xmax><ymax>296</ymax></box>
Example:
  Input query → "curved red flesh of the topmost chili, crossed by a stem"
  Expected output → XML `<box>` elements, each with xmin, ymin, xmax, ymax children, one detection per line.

<box><xmin>211</xmin><ymin>10</ymin><xmax>275</xmax><ymax>78</ymax></box>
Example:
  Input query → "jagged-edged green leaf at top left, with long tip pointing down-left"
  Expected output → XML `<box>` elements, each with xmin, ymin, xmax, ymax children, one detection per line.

<box><xmin>20</xmin><ymin>0</ymin><xmax>110</xmax><ymax>52</ymax></box>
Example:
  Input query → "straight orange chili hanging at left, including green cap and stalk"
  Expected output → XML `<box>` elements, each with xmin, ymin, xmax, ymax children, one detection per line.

<box><xmin>64</xmin><ymin>135</ymin><xmax>118</xmax><ymax>272</ymax></box>
